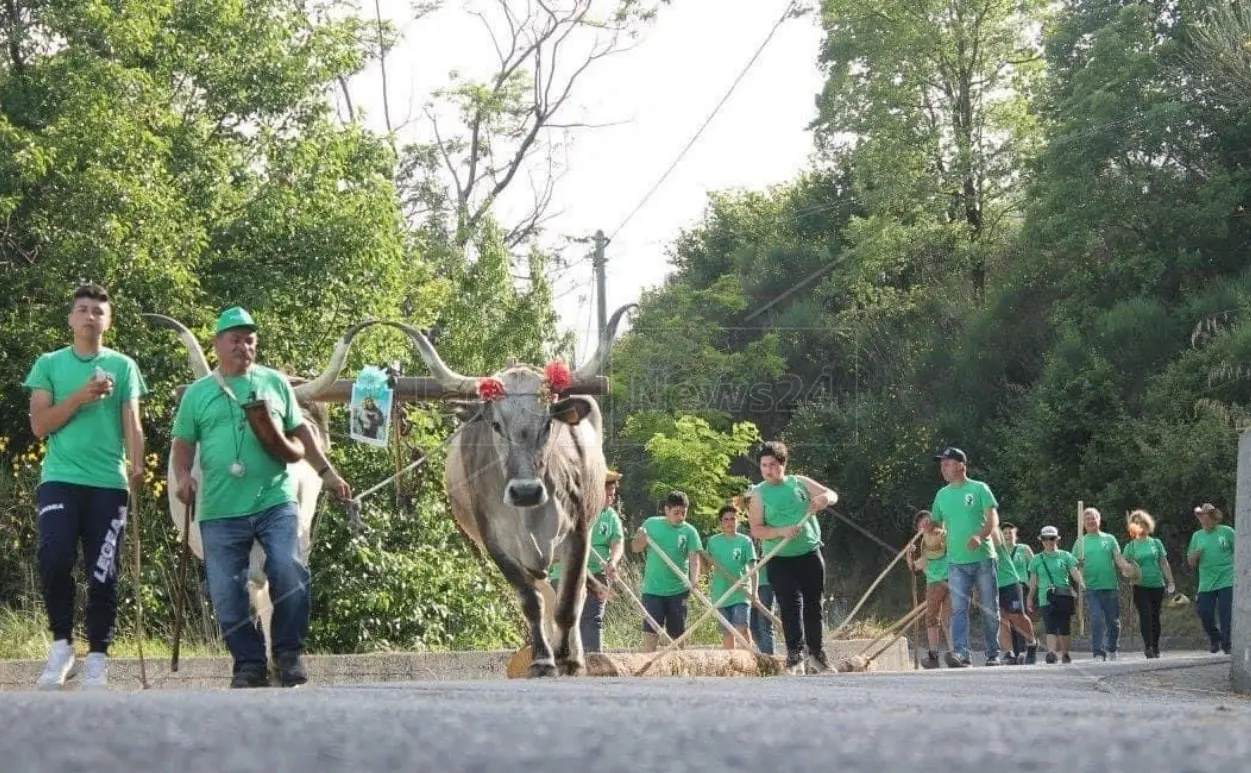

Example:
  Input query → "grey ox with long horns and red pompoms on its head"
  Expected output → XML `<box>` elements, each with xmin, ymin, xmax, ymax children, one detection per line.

<box><xmin>408</xmin><ymin>304</ymin><xmax>637</xmax><ymax>677</ymax></box>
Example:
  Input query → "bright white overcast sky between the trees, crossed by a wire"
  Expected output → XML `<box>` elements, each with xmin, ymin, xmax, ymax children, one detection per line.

<box><xmin>350</xmin><ymin>0</ymin><xmax>821</xmax><ymax>358</ymax></box>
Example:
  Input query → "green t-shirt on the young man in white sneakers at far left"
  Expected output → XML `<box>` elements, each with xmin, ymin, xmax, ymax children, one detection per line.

<box><xmin>23</xmin><ymin>346</ymin><xmax>148</xmax><ymax>490</ymax></box>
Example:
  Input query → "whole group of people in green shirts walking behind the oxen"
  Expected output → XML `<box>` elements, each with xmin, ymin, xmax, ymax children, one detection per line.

<box><xmin>555</xmin><ymin>442</ymin><xmax>1233</xmax><ymax>673</ymax></box>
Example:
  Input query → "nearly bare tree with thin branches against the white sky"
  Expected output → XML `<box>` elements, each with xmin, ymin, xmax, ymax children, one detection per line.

<box><xmin>399</xmin><ymin>0</ymin><xmax>670</xmax><ymax>249</ymax></box>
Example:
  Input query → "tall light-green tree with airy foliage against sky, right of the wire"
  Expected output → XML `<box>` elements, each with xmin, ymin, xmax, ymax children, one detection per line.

<box><xmin>816</xmin><ymin>0</ymin><xmax>1042</xmax><ymax>296</ymax></box>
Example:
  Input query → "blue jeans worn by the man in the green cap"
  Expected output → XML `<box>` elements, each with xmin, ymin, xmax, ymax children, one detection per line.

<box><xmin>200</xmin><ymin>502</ymin><xmax>311</xmax><ymax>673</ymax></box>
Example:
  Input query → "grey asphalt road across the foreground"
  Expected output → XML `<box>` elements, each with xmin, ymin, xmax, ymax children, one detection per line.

<box><xmin>0</xmin><ymin>653</ymin><xmax>1251</xmax><ymax>773</ymax></box>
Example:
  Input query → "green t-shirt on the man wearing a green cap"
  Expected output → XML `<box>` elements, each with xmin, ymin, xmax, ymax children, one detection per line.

<box><xmin>173</xmin><ymin>365</ymin><xmax>304</xmax><ymax>520</ymax></box>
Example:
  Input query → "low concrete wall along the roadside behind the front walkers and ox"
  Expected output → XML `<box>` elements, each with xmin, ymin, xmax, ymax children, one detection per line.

<box><xmin>0</xmin><ymin>639</ymin><xmax>913</xmax><ymax>690</ymax></box>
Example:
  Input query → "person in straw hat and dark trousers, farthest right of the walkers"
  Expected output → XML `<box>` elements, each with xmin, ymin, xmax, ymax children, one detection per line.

<box><xmin>1186</xmin><ymin>502</ymin><xmax>1235</xmax><ymax>654</ymax></box>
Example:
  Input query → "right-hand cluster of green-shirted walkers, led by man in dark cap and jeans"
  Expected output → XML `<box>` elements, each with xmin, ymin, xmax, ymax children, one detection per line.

<box><xmin>908</xmin><ymin>448</ymin><xmax>1235</xmax><ymax>668</ymax></box>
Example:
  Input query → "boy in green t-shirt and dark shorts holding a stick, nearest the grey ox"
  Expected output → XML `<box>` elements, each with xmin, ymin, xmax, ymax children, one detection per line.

<box><xmin>631</xmin><ymin>492</ymin><xmax>703</xmax><ymax>652</ymax></box>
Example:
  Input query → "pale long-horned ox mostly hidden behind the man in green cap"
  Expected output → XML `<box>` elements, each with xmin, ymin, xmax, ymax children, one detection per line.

<box><xmin>144</xmin><ymin>313</ymin><xmax>388</xmax><ymax>668</ymax></box>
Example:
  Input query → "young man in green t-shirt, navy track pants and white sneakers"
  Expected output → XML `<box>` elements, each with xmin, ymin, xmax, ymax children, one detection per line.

<box><xmin>23</xmin><ymin>284</ymin><xmax>148</xmax><ymax>689</ymax></box>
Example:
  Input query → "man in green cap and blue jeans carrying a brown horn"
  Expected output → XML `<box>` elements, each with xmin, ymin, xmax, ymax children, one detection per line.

<box><xmin>173</xmin><ymin>306</ymin><xmax>352</xmax><ymax>687</ymax></box>
